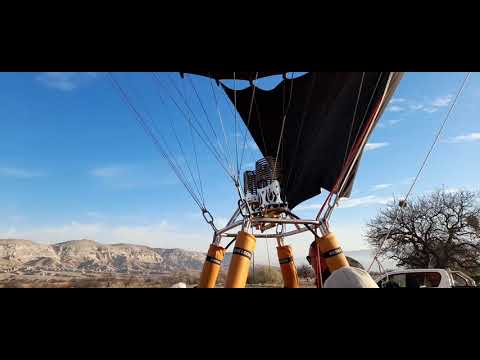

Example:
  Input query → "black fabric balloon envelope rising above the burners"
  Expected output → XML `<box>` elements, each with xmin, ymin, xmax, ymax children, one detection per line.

<box><xmin>182</xmin><ymin>72</ymin><xmax>403</xmax><ymax>209</ymax></box>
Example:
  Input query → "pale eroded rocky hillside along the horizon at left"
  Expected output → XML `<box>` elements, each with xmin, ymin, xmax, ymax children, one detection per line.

<box><xmin>0</xmin><ymin>240</ymin><xmax>224</xmax><ymax>274</ymax></box>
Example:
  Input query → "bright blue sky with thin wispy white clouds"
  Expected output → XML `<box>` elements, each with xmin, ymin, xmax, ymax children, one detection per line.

<box><xmin>0</xmin><ymin>73</ymin><xmax>480</xmax><ymax>262</ymax></box>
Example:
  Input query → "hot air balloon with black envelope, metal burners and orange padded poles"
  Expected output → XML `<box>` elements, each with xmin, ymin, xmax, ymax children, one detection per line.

<box><xmin>108</xmin><ymin>70</ymin><xmax>403</xmax><ymax>288</ymax></box>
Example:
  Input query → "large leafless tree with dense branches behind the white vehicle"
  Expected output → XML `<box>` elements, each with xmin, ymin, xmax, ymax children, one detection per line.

<box><xmin>366</xmin><ymin>190</ymin><xmax>480</xmax><ymax>271</ymax></box>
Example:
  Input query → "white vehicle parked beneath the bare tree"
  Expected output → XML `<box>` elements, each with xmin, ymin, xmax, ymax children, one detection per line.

<box><xmin>375</xmin><ymin>269</ymin><xmax>476</xmax><ymax>288</ymax></box>
